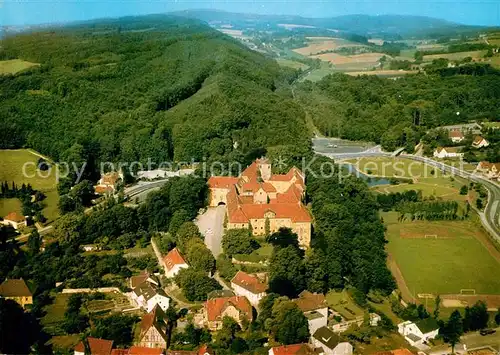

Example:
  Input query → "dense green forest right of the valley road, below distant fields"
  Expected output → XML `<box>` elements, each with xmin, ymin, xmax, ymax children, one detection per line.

<box><xmin>296</xmin><ymin>69</ymin><xmax>500</xmax><ymax>150</ymax></box>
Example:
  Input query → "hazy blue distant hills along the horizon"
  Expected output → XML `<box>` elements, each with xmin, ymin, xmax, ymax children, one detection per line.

<box><xmin>172</xmin><ymin>10</ymin><xmax>485</xmax><ymax>37</ymax></box>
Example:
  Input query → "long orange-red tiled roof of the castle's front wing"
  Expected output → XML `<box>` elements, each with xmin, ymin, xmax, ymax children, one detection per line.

<box><xmin>228</xmin><ymin>203</ymin><xmax>312</xmax><ymax>223</ymax></box>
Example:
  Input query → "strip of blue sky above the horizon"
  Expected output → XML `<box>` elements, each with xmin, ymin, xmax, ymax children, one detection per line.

<box><xmin>0</xmin><ymin>0</ymin><xmax>500</xmax><ymax>26</ymax></box>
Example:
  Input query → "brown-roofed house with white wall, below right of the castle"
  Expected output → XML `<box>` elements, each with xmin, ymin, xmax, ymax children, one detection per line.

<box><xmin>293</xmin><ymin>291</ymin><xmax>328</xmax><ymax>335</ymax></box>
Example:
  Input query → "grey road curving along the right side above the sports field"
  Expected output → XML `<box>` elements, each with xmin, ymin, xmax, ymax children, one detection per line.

<box><xmin>316</xmin><ymin>148</ymin><xmax>500</xmax><ymax>242</ymax></box>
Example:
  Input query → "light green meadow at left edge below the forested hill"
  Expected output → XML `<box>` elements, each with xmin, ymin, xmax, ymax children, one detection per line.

<box><xmin>0</xmin><ymin>149</ymin><xmax>59</xmax><ymax>221</ymax></box>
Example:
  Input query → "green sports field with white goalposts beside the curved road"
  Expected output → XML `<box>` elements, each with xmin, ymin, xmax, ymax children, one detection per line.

<box><xmin>382</xmin><ymin>212</ymin><xmax>500</xmax><ymax>296</ymax></box>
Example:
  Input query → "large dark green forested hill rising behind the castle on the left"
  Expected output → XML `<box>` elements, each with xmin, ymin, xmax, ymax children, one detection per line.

<box><xmin>0</xmin><ymin>15</ymin><xmax>310</xmax><ymax>165</ymax></box>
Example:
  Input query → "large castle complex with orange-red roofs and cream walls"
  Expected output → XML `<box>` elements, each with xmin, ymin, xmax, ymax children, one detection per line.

<box><xmin>208</xmin><ymin>159</ymin><xmax>312</xmax><ymax>248</ymax></box>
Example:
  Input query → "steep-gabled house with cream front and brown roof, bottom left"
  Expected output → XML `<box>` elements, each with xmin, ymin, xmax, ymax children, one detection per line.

<box><xmin>137</xmin><ymin>306</ymin><xmax>168</xmax><ymax>349</ymax></box>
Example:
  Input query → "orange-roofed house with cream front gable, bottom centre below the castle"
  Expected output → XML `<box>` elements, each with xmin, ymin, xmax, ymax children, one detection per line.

<box><xmin>203</xmin><ymin>296</ymin><xmax>253</xmax><ymax>331</ymax></box>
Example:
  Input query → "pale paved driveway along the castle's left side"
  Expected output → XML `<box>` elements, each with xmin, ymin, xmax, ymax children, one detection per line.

<box><xmin>195</xmin><ymin>206</ymin><xmax>226</xmax><ymax>258</ymax></box>
